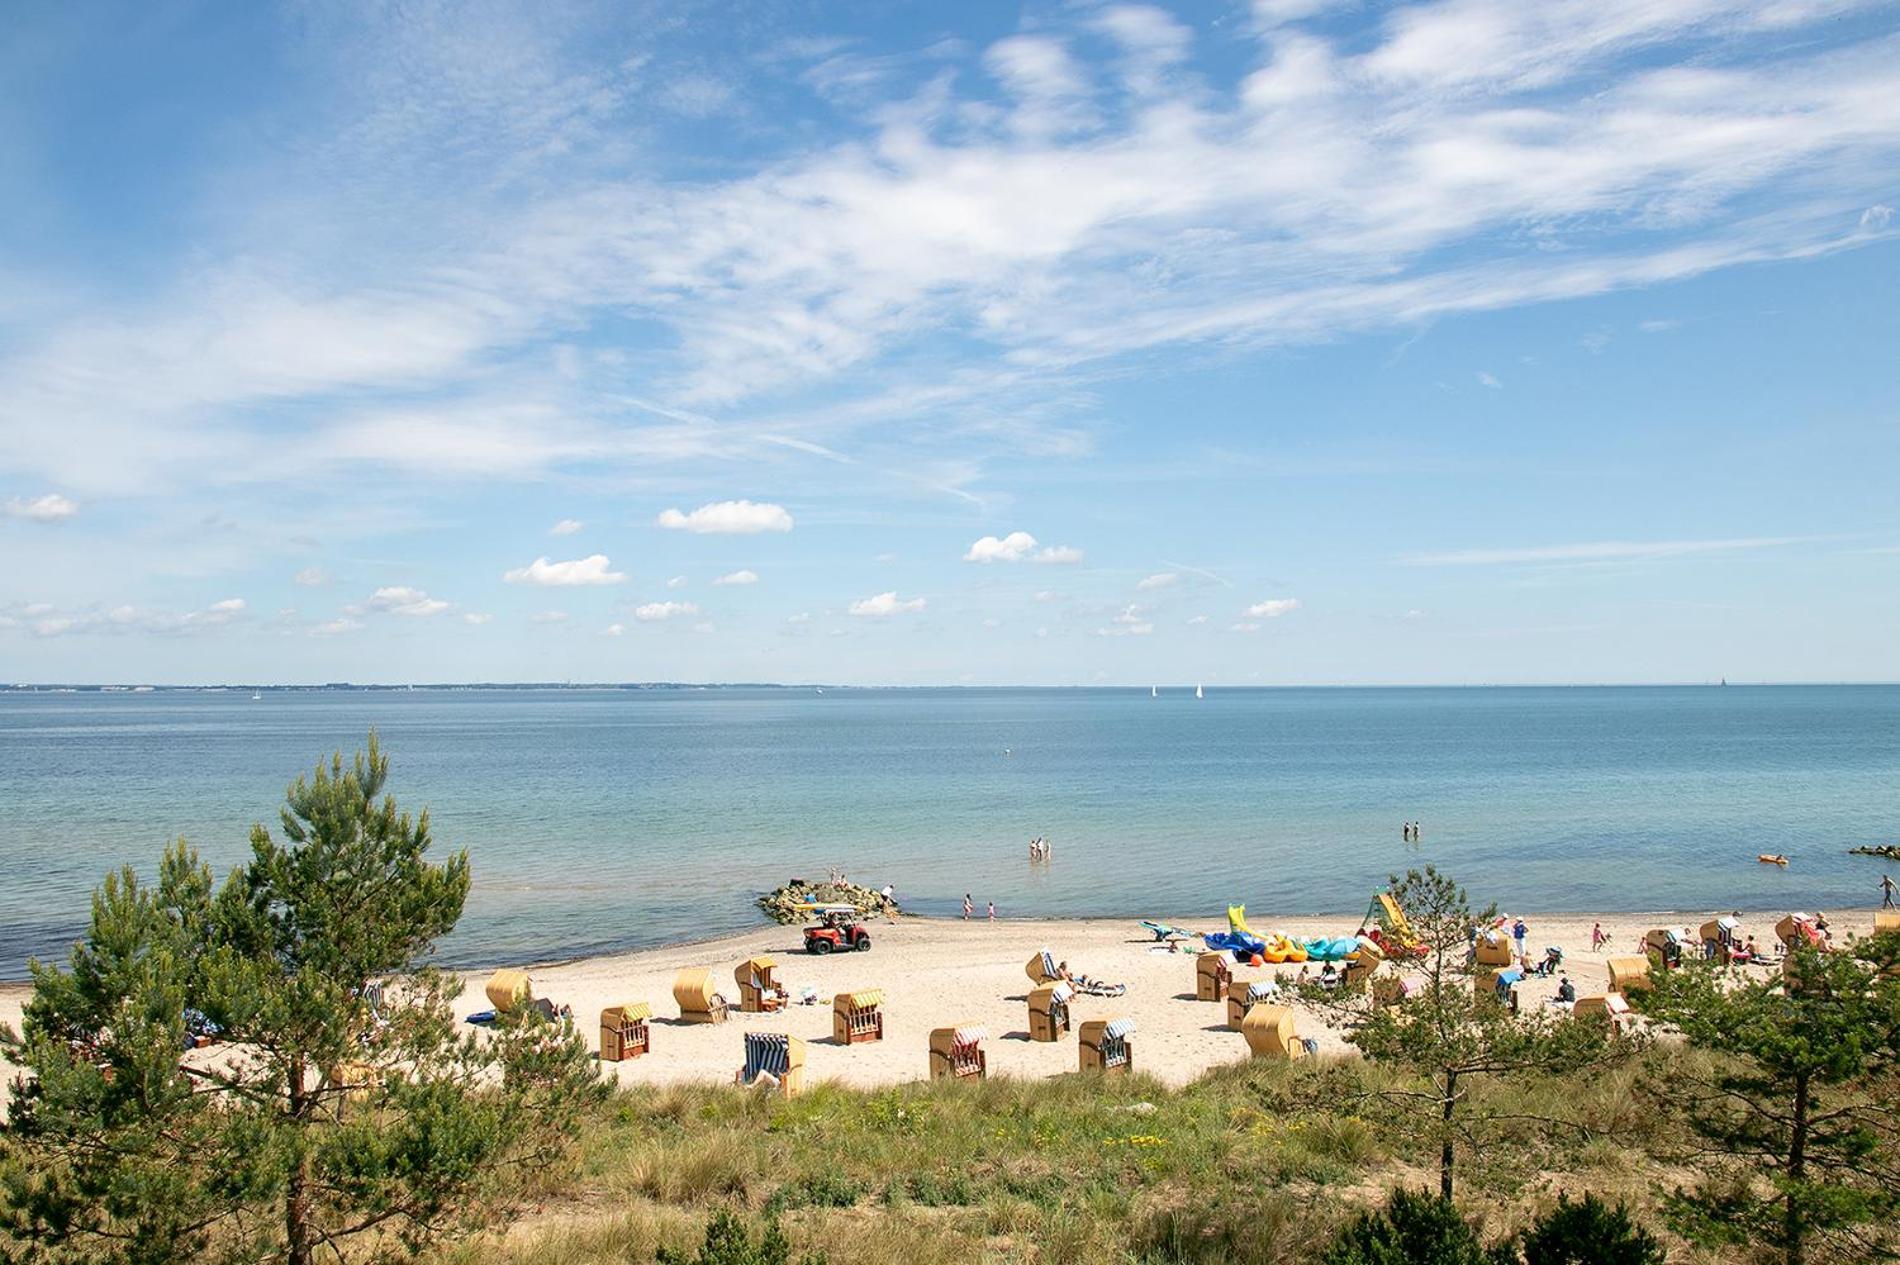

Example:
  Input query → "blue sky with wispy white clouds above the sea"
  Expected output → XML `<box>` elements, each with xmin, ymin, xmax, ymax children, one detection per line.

<box><xmin>0</xmin><ymin>0</ymin><xmax>1900</xmax><ymax>686</ymax></box>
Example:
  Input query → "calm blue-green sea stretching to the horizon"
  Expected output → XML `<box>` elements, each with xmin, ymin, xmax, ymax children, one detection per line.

<box><xmin>0</xmin><ymin>686</ymin><xmax>1900</xmax><ymax>978</ymax></box>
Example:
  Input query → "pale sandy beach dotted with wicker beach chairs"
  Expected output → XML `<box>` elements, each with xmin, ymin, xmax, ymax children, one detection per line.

<box><xmin>0</xmin><ymin>910</ymin><xmax>1873</xmax><ymax>1109</ymax></box>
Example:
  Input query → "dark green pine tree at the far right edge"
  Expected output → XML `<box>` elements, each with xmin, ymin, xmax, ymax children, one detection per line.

<box><xmin>1644</xmin><ymin>935</ymin><xmax>1900</xmax><ymax>1265</ymax></box>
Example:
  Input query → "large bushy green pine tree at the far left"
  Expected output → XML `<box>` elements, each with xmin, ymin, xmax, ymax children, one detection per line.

<box><xmin>0</xmin><ymin>735</ymin><xmax>606</xmax><ymax>1265</ymax></box>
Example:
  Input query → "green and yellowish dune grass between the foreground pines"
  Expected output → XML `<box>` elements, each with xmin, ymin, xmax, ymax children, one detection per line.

<box><xmin>445</xmin><ymin>1050</ymin><xmax>1693</xmax><ymax>1265</ymax></box>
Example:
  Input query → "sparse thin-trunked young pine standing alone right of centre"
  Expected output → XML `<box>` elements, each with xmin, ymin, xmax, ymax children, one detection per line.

<box><xmin>1307</xmin><ymin>866</ymin><xmax>1632</xmax><ymax>1199</ymax></box>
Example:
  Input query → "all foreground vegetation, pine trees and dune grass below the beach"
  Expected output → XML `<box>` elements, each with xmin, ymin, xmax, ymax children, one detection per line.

<box><xmin>0</xmin><ymin>743</ymin><xmax>1900</xmax><ymax>1265</ymax></box>
